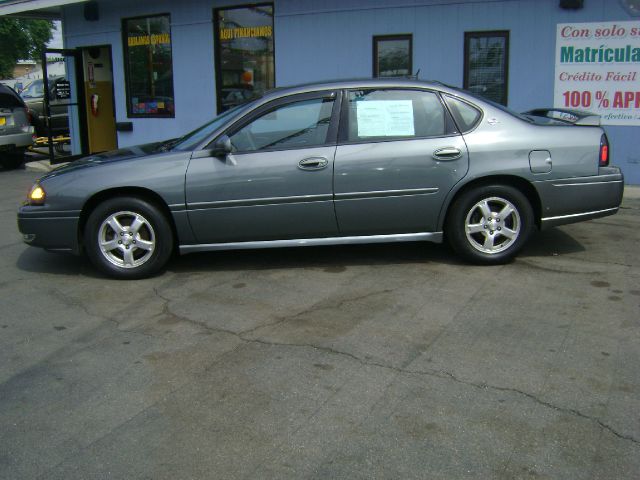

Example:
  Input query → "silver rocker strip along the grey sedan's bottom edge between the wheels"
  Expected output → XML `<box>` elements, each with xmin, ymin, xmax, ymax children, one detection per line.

<box><xmin>179</xmin><ymin>232</ymin><xmax>442</xmax><ymax>254</ymax></box>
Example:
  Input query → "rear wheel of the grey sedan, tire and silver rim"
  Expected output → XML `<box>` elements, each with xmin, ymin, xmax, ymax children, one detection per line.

<box><xmin>445</xmin><ymin>185</ymin><xmax>534</xmax><ymax>265</ymax></box>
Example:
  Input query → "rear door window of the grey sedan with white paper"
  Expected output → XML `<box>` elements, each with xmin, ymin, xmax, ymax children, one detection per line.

<box><xmin>347</xmin><ymin>90</ymin><xmax>447</xmax><ymax>142</ymax></box>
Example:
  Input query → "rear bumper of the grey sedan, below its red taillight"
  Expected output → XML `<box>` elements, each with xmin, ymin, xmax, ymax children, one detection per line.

<box><xmin>533</xmin><ymin>167</ymin><xmax>624</xmax><ymax>229</ymax></box>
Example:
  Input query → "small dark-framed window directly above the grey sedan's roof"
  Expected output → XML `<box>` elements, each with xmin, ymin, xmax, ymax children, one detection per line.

<box><xmin>373</xmin><ymin>35</ymin><xmax>413</xmax><ymax>77</ymax></box>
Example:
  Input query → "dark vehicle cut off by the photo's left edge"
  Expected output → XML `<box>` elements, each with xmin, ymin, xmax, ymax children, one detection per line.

<box><xmin>0</xmin><ymin>84</ymin><xmax>33</xmax><ymax>168</ymax></box>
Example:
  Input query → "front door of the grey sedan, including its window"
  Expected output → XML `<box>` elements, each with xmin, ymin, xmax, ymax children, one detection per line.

<box><xmin>186</xmin><ymin>91</ymin><xmax>339</xmax><ymax>243</ymax></box>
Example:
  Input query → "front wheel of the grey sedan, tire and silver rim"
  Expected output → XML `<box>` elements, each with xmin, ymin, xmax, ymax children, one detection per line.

<box><xmin>84</xmin><ymin>197</ymin><xmax>174</xmax><ymax>279</ymax></box>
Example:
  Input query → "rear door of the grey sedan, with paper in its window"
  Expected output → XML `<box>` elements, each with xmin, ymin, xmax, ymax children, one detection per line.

<box><xmin>334</xmin><ymin>88</ymin><xmax>469</xmax><ymax>235</ymax></box>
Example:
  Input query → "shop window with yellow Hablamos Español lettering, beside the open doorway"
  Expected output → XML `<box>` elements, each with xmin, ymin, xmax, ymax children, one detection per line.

<box><xmin>122</xmin><ymin>15</ymin><xmax>175</xmax><ymax>117</ymax></box>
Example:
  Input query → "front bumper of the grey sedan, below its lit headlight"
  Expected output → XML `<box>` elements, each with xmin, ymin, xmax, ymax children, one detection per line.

<box><xmin>18</xmin><ymin>206</ymin><xmax>81</xmax><ymax>254</ymax></box>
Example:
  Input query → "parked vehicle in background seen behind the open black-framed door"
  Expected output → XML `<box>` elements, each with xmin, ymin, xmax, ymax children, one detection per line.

<box><xmin>20</xmin><ymin>76</ymin><xmax>69</xmax><ymax>137</ymax></box>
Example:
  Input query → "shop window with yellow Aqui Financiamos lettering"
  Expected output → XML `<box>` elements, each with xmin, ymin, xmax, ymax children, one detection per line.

<box><xmin>213</xmin><ymin>4</ymin><xmax>275</xmax><ymax>112</ymax></box>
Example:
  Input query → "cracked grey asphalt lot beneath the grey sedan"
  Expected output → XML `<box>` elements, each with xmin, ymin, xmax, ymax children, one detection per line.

<box><xmin>0</xmin><ymin>170</ymin><xmax>640</xmax><ymax>480</ymax></box>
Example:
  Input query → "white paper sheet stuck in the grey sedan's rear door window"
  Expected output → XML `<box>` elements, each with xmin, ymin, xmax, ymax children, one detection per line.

<box><xmin>356</xmin><ymin>100</ymin><xmax>415</xmax><ymax>137</ymax></box>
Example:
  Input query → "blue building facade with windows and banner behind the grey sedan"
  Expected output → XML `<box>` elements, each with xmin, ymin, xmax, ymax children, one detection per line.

<box><xmin>0</xmin><ymin>0</ymin><xmax>640</xmax><ymax>184</ymax></box>
